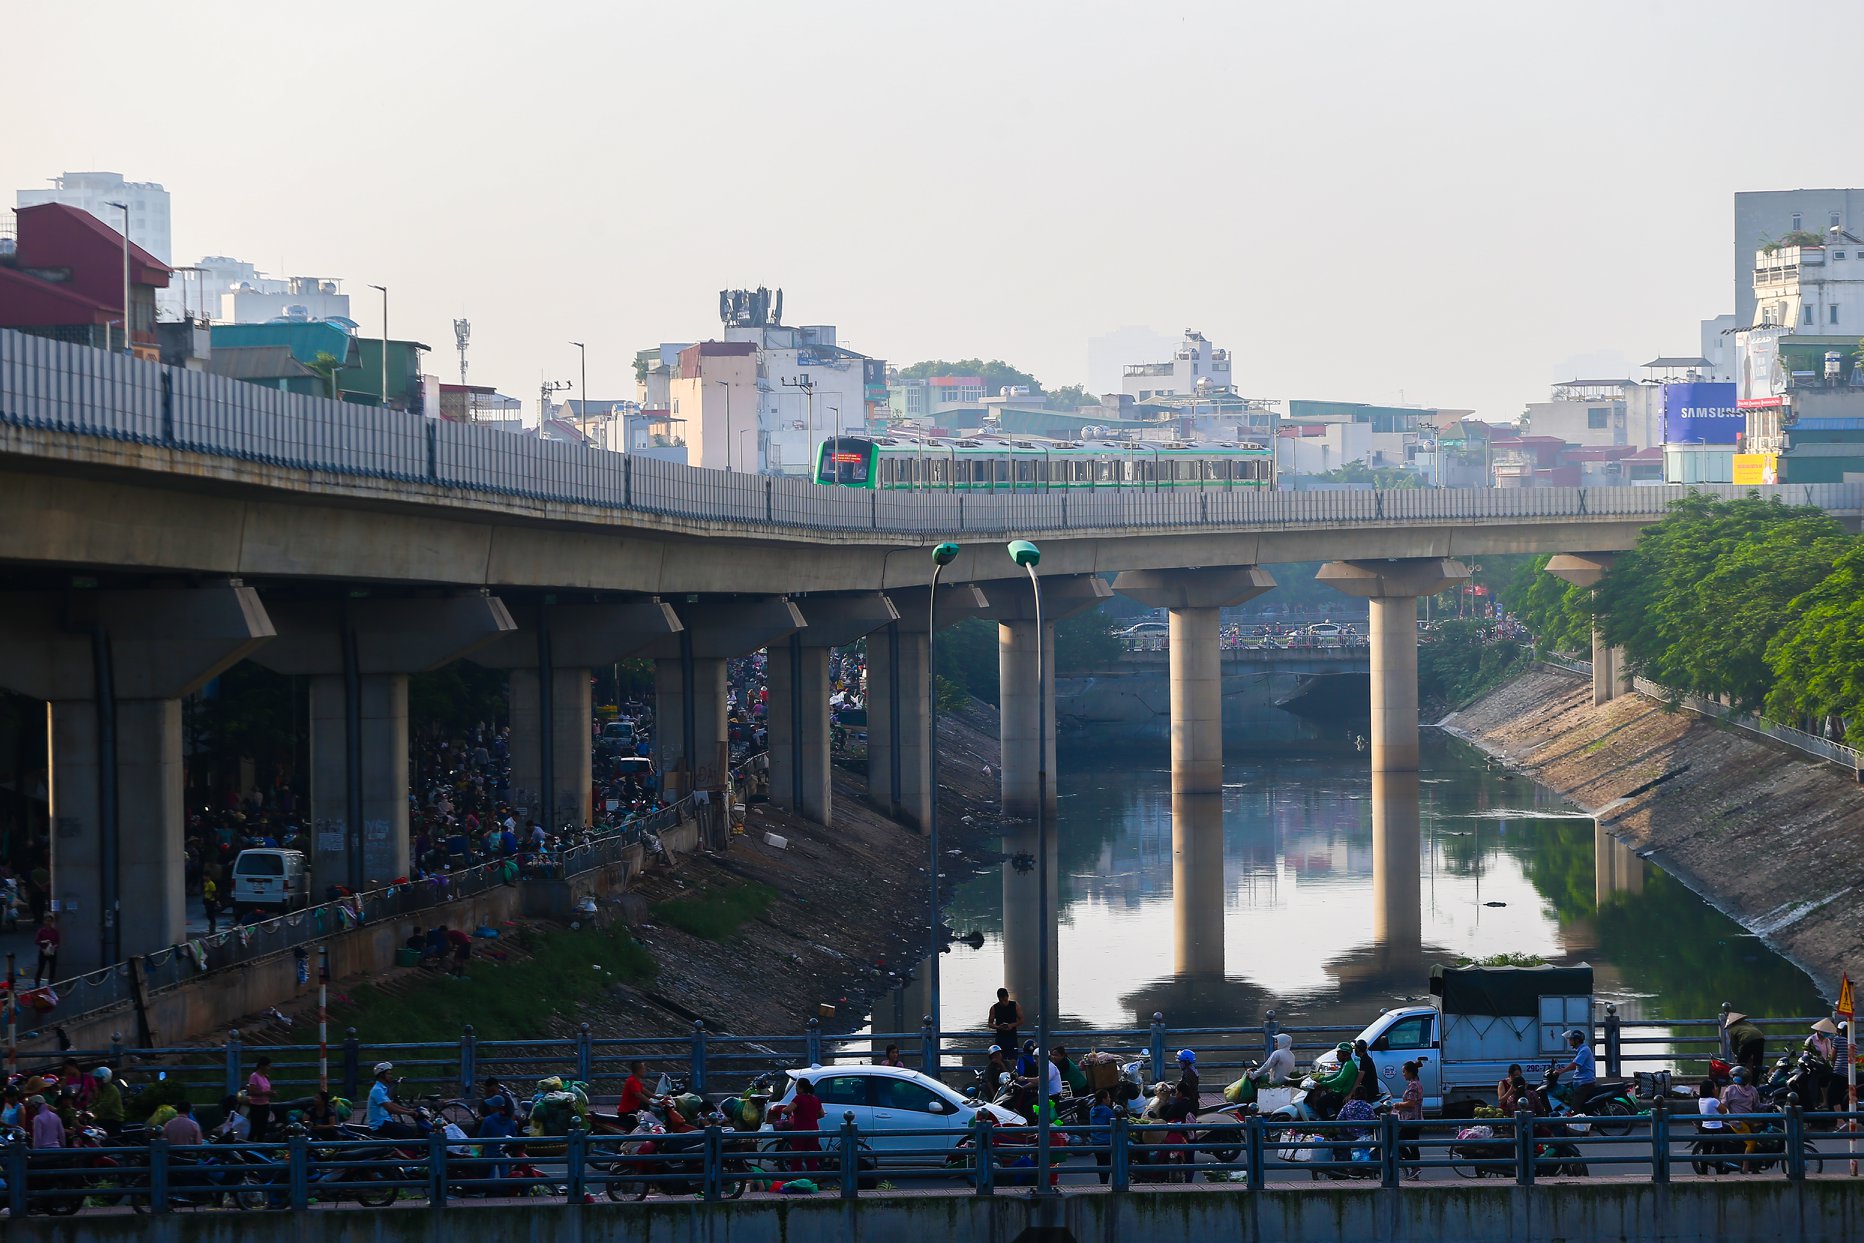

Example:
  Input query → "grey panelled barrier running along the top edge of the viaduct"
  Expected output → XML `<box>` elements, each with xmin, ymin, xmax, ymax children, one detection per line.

<box><xmin>0</xmin><ymin>332</ymin><xmax>1864</xmax><ymax>537</ymax></box>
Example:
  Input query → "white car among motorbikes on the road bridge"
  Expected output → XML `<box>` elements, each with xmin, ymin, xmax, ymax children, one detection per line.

<box><xmin>762</xmin><ymin>1066</ymin><xmax>1027</xmax><ymax>1165</ymax></box>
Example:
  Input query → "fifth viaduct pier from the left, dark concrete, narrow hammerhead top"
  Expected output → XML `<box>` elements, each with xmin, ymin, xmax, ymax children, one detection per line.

<box><xmin>766</xmin><ymin>593</ymin><xmax>900</xmax><ymax>824</ymax></box>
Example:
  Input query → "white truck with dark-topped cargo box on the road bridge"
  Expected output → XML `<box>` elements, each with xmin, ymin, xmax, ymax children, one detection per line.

<box><xmin>1314</xmin><ymin>963</ymin><xmax>1592</xmax><ymax>1114</ymax></box>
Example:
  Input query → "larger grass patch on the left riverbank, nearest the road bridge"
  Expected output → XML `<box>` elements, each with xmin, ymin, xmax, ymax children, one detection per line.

<box><xmin>291</xmin><ymin>924</ymin><xmax>658</xmax><ymax>1044</ymax></box>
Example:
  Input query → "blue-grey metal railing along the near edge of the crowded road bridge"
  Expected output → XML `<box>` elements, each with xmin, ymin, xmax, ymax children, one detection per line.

<box><xmin>0</xmin><ymin>1098</ymin><xmax>1860</xmax><ymax>1221</ymax></box>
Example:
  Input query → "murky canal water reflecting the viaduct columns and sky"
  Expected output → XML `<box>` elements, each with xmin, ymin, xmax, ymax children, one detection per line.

<box><xmin>898</xmin><ymin>731</ymin><xmax>1823</xmax><ymax>1058</ymax></box>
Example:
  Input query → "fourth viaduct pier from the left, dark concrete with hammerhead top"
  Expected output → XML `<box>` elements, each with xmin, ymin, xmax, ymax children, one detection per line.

<box><xmin>643</xmin><ymin>596</ymin><xmax>805</xmax><ymax>796</ymax></box>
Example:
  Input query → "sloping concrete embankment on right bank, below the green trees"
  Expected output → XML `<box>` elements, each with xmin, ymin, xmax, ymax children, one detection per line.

<box><xmin>1445</xmin><ymin>665</ymin><xmax>1864</xmax><ymax>997</ymax></box>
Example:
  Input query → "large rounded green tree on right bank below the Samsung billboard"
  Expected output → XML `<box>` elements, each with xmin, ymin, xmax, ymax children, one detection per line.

<box><xmin>1594</xmin><ymin>496</ymin><xmax>1849</xmax><ymax>710</ymax></box>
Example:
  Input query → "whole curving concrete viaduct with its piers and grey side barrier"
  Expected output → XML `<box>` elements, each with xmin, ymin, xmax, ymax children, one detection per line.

<box><xmin>0</xmin><ymin>332</ymin><xmax>1864</xmax><ymax>971</ymax></box>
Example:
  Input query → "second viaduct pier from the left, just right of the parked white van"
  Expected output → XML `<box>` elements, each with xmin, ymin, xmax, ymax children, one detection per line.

<box><xmin>255</xmin><ymin>593</ymin><xmax>516</xmax><ymax>898</ymax></box>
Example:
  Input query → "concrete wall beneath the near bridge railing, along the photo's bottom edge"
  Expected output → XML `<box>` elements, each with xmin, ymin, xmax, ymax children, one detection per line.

<box><xmin>7</xmin><ymin>1178</ymin><xmax>1864</xmax><ymax>1243</ymax></box>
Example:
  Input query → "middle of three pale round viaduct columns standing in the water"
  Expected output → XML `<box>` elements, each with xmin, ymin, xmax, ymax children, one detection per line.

<box><xmin>1113</xmin><ymin>565</ymin><xmax>1275</xmax><ymax>794</ymax></box>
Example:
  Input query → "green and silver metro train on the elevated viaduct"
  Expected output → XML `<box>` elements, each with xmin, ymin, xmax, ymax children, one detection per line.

<box><xmin>813</xmin><ymin>436</ymin><xmax>1275</xmax><ymax>492</ymax></box>
